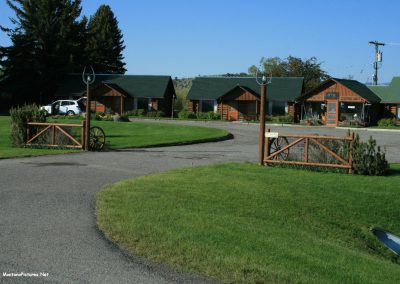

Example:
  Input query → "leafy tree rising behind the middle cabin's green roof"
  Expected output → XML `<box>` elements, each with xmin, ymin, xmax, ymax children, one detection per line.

<box><xmin>248</xmin><ymin>56</ymin><xmax>329</xmax><ymax>91</ymax></box>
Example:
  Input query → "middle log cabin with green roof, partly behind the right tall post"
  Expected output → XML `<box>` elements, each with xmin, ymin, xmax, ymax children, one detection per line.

<box><xmin>188</xmin><ymin>77</ymin><xmax>303</xmax><ymax>121</ymax></box>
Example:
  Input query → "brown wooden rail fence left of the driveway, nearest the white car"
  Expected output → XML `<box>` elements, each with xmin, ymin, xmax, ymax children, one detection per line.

<box><xmin>26</xmin><ymin>121</ymin><xmax>85</xmax><ymax>149</ymax></box>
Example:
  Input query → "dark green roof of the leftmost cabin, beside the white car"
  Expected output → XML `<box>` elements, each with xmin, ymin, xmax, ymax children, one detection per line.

<box><xmin>56</xmin><ymin>74</ymin><xmax>175</xmax><ymax>98</ymax></box>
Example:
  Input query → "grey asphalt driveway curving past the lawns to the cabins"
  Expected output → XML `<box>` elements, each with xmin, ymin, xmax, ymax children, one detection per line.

<box><xmin>0</xmin><ymin>122</ymin><xmax>400</xmax><ymax>283</ymax></box>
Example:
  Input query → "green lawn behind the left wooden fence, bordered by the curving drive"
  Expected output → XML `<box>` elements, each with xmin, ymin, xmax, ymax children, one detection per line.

<box><xmin>0</xmin><ymin>116</ymin><xmax>228</xmax><ymax>158</ymax></box>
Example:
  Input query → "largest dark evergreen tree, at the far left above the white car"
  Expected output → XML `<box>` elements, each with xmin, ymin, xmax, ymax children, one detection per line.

<box><xmin>0</xmin><ymin>0</ymin><xmax>87</xmax><ymax>104</ymax></box>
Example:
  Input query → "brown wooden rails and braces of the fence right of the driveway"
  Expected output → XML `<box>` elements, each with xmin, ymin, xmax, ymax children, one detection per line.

<box><xmin>264</xmin><ymin>129</ymin><xmax>354</xmax><ymax>174</ymax></box>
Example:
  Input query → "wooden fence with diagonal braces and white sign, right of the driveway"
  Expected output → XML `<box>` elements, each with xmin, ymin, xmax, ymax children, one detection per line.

<box><xmin>264</xmin><ymin>129</ymin><xmax>354</xmax><ymax>174</ymax></box>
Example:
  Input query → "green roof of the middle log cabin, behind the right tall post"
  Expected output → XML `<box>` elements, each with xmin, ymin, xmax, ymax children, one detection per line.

<box><xmin>188</xmin><ymin>77</ymin><xmax>303</xmax><ymax>102</ymax></box>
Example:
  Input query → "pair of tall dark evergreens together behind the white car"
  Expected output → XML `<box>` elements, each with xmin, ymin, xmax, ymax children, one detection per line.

<box><xmin>0</xmin><ymin>0</ymin><xmax>126</xmax><ymax>104</ymax></box>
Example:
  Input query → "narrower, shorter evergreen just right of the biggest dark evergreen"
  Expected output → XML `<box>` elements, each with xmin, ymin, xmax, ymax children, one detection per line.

<box><xmin>86</xmin><ymin>5</ymin><xmax>126</xmax><ymax>74</ymax></box>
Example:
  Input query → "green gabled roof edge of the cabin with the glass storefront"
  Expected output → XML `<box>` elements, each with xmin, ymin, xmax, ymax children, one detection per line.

<box><xmin>296</xmin><ymin>78</ymin><xmax>381</xmax><ymax>103</ymax></box>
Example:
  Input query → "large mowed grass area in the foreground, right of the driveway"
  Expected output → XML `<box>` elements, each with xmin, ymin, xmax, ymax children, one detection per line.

<box><xmin>96</xmin><ymin>163</ymin><xmax>400</xmax><ymax>283</ymax></box>
